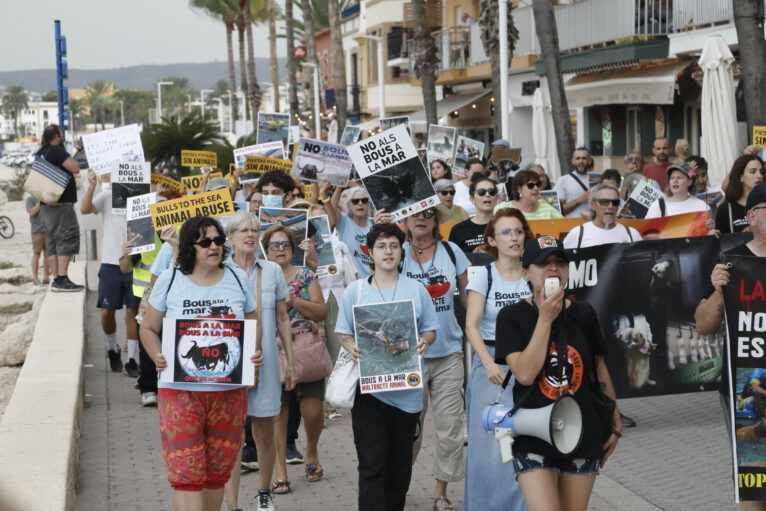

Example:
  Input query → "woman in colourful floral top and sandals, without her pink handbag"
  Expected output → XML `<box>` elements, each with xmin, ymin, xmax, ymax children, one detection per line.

<box><xmin>263</xmin><ymin>224</ymin><xmax>327</xmax><ymax>494</ymax></box>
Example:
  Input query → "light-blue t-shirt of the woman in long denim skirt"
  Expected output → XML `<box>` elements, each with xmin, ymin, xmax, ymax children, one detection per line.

<box><xmin>465</xmin><ymin>263</ymin><xmax>532</xmax><ymax>341</ymax></box>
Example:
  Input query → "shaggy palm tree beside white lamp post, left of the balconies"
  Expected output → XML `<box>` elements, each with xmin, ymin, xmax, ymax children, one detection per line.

<box><xmin>479</xmin><ymin>0</ymin><xmax>519</xmax><ymax>138</ymax></box>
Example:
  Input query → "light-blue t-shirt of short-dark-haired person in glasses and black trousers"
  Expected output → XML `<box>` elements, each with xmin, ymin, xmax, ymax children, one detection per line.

<box><xmin>335</xmin><ymin>275</ymin><xmax>439</xmax><ymax>413</ymax></box>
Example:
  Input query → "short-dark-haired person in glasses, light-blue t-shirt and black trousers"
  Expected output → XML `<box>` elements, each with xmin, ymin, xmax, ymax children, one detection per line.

<box><xmin>335</xmin><ymin>223</ymin><xmax>438</xmax><ymax>511</ymax></box>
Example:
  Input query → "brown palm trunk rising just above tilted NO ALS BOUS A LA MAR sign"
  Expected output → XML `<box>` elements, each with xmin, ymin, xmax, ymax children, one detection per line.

<box><xmin>414</xmin><ymin>0</ymin><xmax>439</xmax><ymax>125</ymax></box>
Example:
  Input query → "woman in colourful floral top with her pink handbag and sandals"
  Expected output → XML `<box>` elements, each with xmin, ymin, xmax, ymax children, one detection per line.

<box><xmin>263</xmin><ymin>224</ymin><xmax>332</xmax><ymax>494</ymax></box>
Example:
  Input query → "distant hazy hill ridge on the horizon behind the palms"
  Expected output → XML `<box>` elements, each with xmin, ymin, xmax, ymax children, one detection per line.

<box><xmin>0</xmin><ymin>58</ymin><xmax>287</xmax><ymax>93</ymax></box>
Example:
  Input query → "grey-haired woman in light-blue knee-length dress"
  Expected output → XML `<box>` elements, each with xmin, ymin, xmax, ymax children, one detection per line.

<box><xmin>226</xmin><ymin>211</ymin><xmax>295</xmax><ymax>509</ymax></box>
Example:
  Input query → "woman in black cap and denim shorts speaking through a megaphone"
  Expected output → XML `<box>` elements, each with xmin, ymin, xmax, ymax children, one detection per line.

<box><xmin>495</xmin><ymin>236</ymin><xmax>622</xmax><ymax>511</ymax></box>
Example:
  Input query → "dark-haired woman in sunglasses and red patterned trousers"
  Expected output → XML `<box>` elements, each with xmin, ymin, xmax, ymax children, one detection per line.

<box><xmin>141</xmin><ymin>216</ymin><xmax>263</xmax><ymax>511</ymax></box>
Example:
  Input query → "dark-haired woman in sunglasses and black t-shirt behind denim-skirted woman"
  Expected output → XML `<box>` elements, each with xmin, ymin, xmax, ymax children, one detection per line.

<box><xmin>449</xmin><ymin>173</ymin><xmax>497</xmax><ymax>252</ymax></box>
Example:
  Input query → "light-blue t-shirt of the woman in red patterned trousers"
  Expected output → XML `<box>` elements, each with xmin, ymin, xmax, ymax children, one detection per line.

<box><xmin>149</xmin><ymin>264</ymin><xmax>263</xmax><ymax>392</ymax></box>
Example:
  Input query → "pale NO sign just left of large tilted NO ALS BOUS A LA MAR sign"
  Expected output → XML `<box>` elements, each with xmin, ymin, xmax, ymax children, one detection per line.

<box><xmin>292</xmin><ymin>138</ymin><xmax>352</xmax><ymax>187</ymax></box>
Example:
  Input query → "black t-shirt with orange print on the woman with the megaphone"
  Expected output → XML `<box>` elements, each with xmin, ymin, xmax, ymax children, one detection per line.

<box><xmin>495</xmin><ymin>300</ymin><xmax>606</xmax><ymax>458</ymax></box>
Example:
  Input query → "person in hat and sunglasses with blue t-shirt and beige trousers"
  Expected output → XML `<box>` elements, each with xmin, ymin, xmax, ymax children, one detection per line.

<box><xmin>403</xmin><ymin>206</ymin><xmax>471</xmax><ymax>511</ymax></box>
